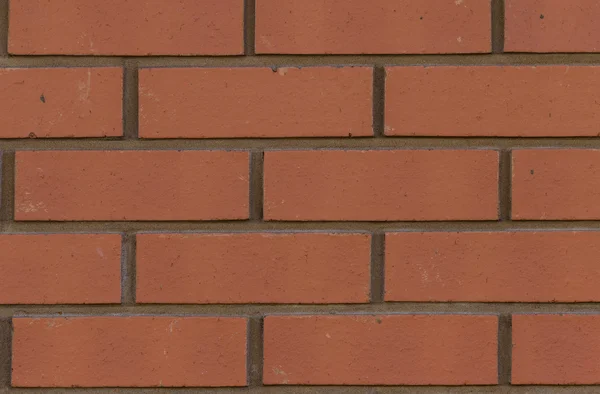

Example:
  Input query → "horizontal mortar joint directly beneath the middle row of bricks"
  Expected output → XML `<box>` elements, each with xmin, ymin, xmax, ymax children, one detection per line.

<box><xmin>3</xmin><ymin>220</ymin><xmax>600</xmax><ymax>233</ymax></box>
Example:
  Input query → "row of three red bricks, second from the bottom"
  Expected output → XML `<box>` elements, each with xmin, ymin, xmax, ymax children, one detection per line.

<box><xmin>0</xmin><ymin>231</ymin><xmax>600</xmax><ymax>304</ymax></box>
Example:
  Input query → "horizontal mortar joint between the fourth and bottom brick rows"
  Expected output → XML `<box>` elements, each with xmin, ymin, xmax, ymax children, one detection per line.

<box><xmin>5</xmin><ymin>301</ymin><xmax>600</xmax><ymax>317</ymax></box>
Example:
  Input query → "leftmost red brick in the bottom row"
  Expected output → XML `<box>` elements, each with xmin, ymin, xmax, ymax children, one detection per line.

<box><xmin>12</xmin><ymin>317</ymin><xmax>247</xmax><ymax>387</ymax></box>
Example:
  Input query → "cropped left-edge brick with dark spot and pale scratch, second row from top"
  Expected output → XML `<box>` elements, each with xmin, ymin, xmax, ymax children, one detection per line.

<box><xmin>0</xmin><ymin>68</ymin><xmax>123</xmax><ymax>138</ymax></box>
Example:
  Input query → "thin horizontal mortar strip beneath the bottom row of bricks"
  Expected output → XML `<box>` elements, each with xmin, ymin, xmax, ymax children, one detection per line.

<box><xmin>0</xmin><ymin>385</ymin><xmax>598</xmax><ymax>394</ymax></box>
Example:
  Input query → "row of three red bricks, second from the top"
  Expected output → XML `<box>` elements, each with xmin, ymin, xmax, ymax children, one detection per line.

<box><xmin>0</xmin><ymin>66</ymin><xmax>600</xmax><ymax>139</ymax></box>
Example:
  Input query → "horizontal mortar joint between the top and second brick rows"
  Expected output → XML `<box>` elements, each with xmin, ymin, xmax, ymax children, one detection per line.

<box><xmin>0</xmin><ymin>53</ymin><xmax>600</xmax><ymax>67</ymax></box>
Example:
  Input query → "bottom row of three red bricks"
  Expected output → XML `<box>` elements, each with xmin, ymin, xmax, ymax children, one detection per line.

<box><xmin>12</xmin><ymin>314</ymin><xmax>600</xmax><ymax>387</ymax></box>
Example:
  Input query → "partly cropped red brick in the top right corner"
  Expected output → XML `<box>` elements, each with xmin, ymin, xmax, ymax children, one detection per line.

<box><xmin>504</xmin><ymin>0</ymin><xmax>600</xmax><ymax>52</ymax></box>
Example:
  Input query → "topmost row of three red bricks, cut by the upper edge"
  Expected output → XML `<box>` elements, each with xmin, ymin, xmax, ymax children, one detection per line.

<box><xmin>8</xmin><ymin>0</ymin><xmax>600</xmax><ymax>56</ymax></box>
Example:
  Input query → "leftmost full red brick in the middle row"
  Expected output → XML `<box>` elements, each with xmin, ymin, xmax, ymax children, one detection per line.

<box><xmin>15</xmin><ymin>151</ymin><xmax>249</xmax><ymax>221</ymax></box>
